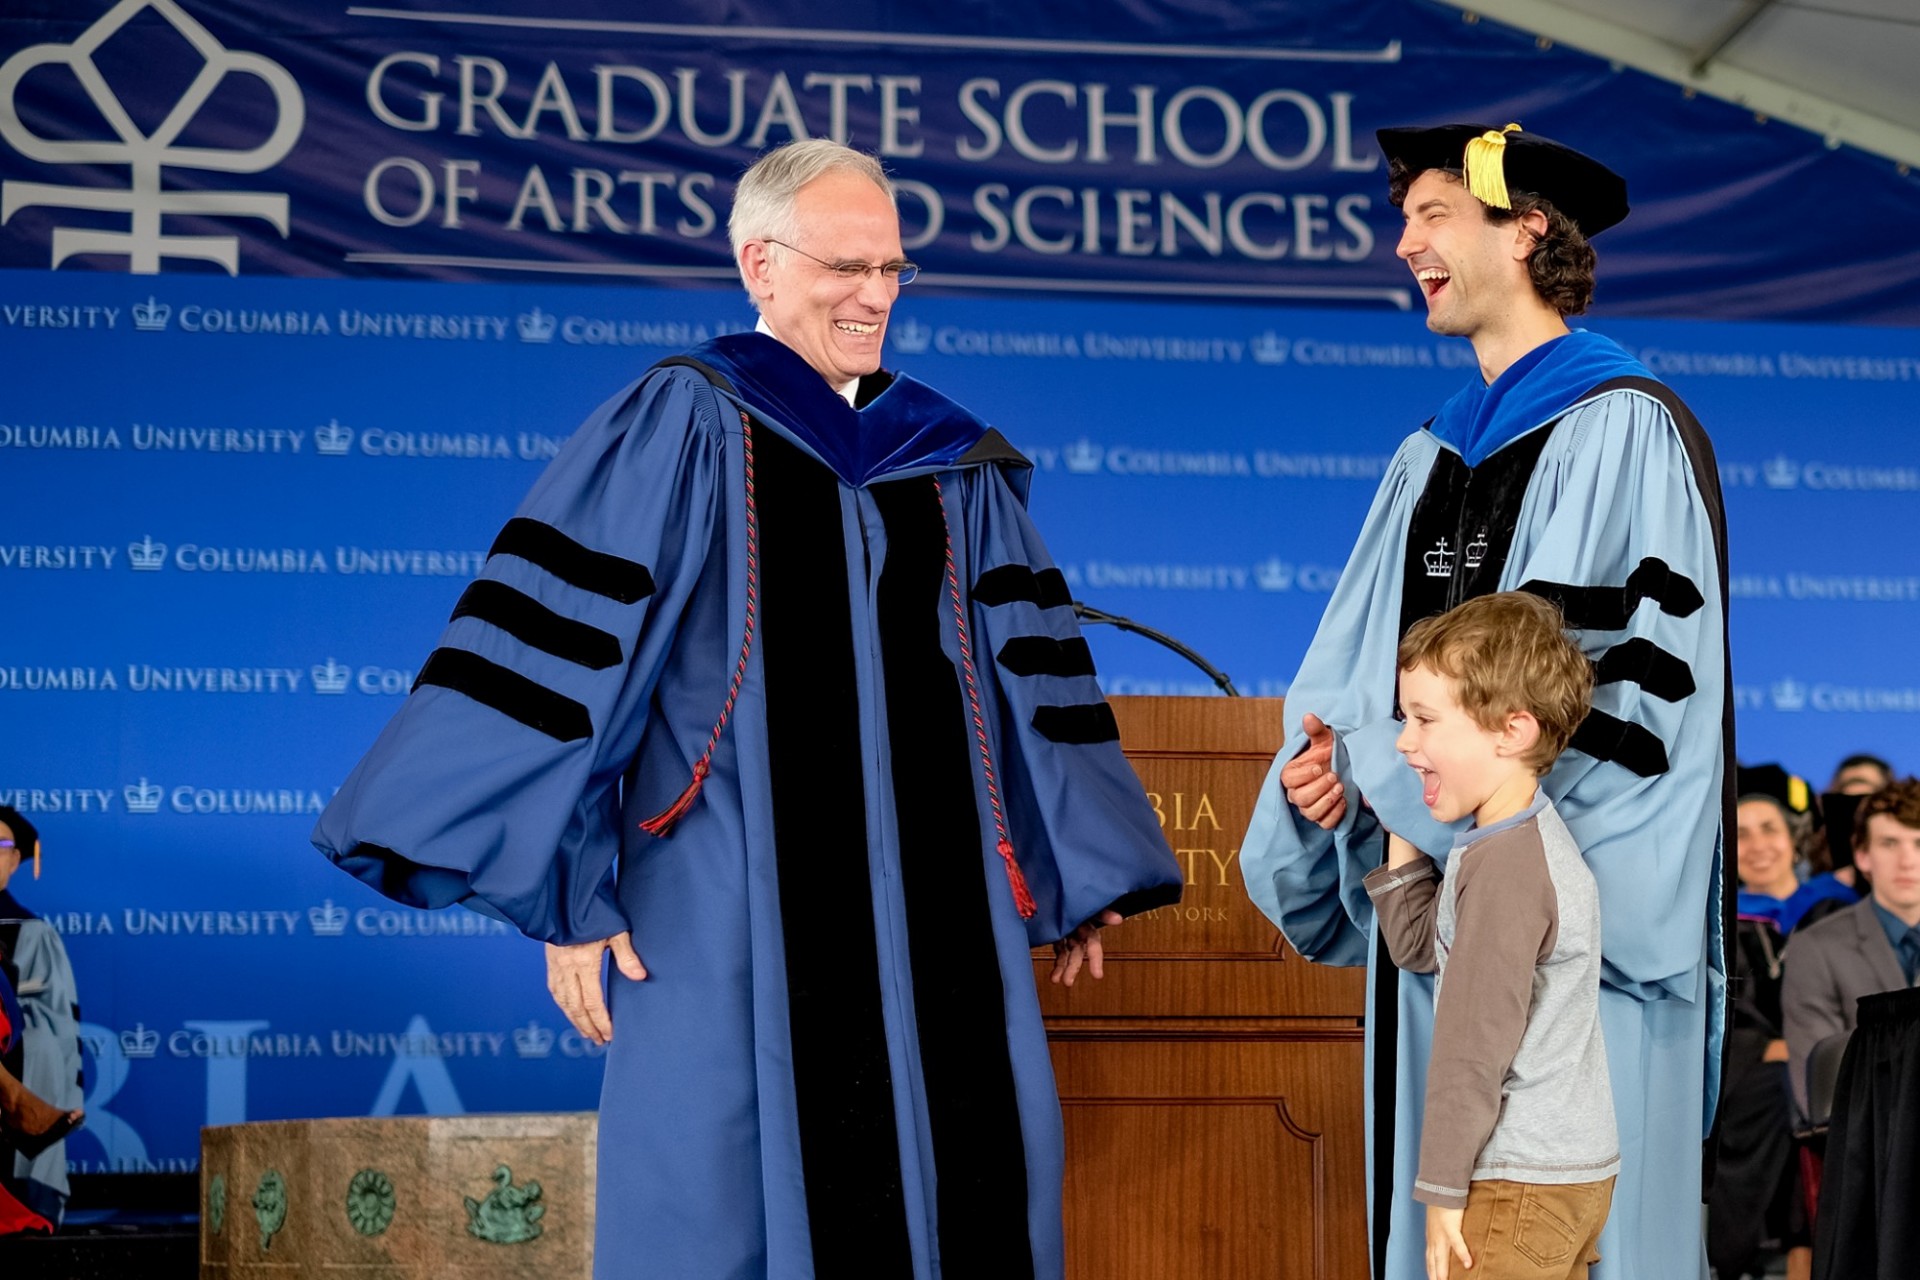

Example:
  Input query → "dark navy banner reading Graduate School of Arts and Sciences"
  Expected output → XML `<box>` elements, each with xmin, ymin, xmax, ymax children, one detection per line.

<box><xmin>0</xmin><ymin>0</ymin><xmax>1920</xmax><ymax>324</ymax></box>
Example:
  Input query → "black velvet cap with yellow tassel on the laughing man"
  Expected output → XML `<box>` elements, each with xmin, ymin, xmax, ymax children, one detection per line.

<box><xmin>1373</xmin><ymin>125</ymin><xmax>1626</xmax><ymax>238</ymax></box>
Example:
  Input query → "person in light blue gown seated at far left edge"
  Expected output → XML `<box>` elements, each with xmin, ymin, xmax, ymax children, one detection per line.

<box><xmin>0</xmin><ymin>804</ymin><xmax>84</xmax><ymax>1226</ymax></box>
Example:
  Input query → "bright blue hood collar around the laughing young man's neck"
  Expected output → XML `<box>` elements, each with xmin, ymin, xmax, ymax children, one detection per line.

<box><xmin>1428</xmin><ymin>328</ymin><xmax>1653</xmax><ymax>466</ymax></box>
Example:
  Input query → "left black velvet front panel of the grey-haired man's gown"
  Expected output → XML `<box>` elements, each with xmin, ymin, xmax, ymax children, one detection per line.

<box><xmin>755</xmin><ymin>430</ymin><xmax>914</xmax><ymax>1280</ymax></box>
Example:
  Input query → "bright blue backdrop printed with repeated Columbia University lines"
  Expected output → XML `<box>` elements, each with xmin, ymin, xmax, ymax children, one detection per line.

<box><xmin>0</xmin><ymin>273</ymin><xmax>1920</xmax><ymax>1169</ymax></box>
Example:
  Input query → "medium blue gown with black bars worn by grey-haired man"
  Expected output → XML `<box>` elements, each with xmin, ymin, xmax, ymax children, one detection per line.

<box><xmin>315</xmin><ymin>334</ymin><xmax>1179</xmax><ymax>1280</ymax></box>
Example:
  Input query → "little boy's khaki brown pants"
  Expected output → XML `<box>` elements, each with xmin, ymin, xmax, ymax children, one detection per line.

<box><xmin>1448</xmin><ymin>1178</ymin><xmax>1613</xmax><ymax>1280</ymax></box>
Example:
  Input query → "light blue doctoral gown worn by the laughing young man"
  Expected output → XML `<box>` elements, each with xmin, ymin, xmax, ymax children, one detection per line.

<box><xmin>1240</xmin><ymin>340</ymin><xmax>1732</xmax><ymax>1280</ymax></box>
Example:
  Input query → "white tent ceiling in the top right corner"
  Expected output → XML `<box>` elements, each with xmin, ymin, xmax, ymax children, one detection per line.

<box><xmin>1442</xmin><ymin>0</ymin><xmax>1920</xmax><ymax>173</ymax></box>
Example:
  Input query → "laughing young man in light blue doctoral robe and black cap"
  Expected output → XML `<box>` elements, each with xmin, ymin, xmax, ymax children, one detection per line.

<box><xmin>1240</xmin><ymin>125</ymin><xmax>1734</xmax><ymax>1280</ymax></box>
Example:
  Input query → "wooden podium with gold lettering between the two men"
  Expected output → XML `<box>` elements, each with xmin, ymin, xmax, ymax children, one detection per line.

<box><xmin>1035</xmin><ymin>697</ymin><xmax>1367</xmax><ymax>1280</ymax></box>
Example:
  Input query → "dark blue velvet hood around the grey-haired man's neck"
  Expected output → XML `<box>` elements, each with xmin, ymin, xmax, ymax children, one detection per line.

<box><xmin>687</xmin><ymin>334</ymin><xmax>991</xmax><ymax>487</ymax></box>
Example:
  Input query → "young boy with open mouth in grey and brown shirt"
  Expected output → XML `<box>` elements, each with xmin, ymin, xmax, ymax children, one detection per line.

<box><xmin>1367</xmin><ymin>591</ymin><xmax>1620</xmax><ymax>1280</ymax></box>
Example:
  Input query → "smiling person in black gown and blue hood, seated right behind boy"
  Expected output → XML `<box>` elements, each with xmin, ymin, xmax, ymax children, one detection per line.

<box><xmin>1707</xmin><ymin>790</ymin><xmax>1812</xmax><ymax>1280</ymax></box>
